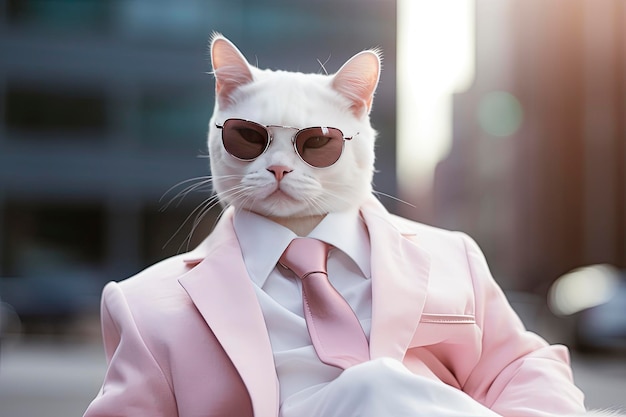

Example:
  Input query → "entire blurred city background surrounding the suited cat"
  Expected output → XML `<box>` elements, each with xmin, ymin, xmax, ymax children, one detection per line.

<box><xmin>0</xmin><ymin>0</ymin><xmax>626</xmax><ymax>417</ymax></box>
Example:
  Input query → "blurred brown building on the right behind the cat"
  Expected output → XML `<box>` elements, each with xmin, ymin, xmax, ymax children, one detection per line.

<box><xmin>433</xmin><ymin>0</ymin><xmax>626</xmax><ymax>294</ymax></box>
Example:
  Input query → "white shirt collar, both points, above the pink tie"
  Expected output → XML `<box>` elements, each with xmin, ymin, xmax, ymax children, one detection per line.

<box><xmin>233</xmin><ymin>209</ymin><xmax>371</xmax><ymax>287</ymax></box>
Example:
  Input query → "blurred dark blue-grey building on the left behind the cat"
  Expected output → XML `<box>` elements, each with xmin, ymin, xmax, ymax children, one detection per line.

<box><xmin>0</xmin><ymin>0</ymin><xmax>395</xmax><ymax>332</ymax></box>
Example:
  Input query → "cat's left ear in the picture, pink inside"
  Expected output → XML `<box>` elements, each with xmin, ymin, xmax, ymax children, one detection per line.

<box><xmin>211</xmin><ymin>34</ymin><xmax>253</xmax><ymax>108</ymax></box>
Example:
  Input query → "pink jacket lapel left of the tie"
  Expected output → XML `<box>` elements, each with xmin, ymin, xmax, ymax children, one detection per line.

<box><xmin>179</xmin><ymin>210</ymin><xmax>278</xmax><ymax>416</ymax></box>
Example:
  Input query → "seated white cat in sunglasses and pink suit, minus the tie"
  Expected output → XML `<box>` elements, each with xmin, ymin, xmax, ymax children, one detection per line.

<box><xmin>85</xmin><ymin>35</ymin><xmax>614</xmax><ymax>417</ymax></box>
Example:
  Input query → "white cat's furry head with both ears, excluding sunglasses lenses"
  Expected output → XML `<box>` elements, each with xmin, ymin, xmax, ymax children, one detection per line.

<box><xmin>208</xmin><ymin>34</ymin><xmax>380</xmax><ymax>218</ymax></box>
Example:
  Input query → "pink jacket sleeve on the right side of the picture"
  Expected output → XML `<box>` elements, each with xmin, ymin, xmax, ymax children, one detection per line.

<box><xmin>463</xmin><ymin>235</ymin><xmax>585</xmax><ymax>417</ymax></box>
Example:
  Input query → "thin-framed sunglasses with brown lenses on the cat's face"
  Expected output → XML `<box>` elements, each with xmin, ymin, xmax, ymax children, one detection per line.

<box><xmin>215</xmin><ymin>119</ymin><xmax>358</xmax><ymax>168</ymax></box>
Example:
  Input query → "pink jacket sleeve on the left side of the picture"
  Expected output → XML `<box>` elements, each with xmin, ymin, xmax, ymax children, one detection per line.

<box><xmin>84</xmin><ymin>283</ymin><xmax>178</xmax><ymax>417</ymax></box>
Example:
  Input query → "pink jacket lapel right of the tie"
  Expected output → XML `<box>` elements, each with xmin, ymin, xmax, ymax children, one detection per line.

<box><xmin>361</xmin><ymin>198</ymin><xmax>430</xmax><ymax>361</ymax></box>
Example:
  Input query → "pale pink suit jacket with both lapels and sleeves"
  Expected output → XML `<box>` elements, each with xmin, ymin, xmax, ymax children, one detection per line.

<box><xmin>85</xmin><ymin>198</ymin><xmax>584</xmax><ymax>417</ymax></box>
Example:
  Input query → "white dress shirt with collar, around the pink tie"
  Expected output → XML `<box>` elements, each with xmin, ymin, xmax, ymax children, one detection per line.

<box><xmin>234</xmin><ymin>210</ymin><xmax>372</xmax><ymax>404</ymax></box>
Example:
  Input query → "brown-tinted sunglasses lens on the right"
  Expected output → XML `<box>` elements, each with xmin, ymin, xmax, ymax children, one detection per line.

<box><xmin>296</xmin><ymin>127</ymin><xmax>343</xmax><ymax>168</ymax></box>
